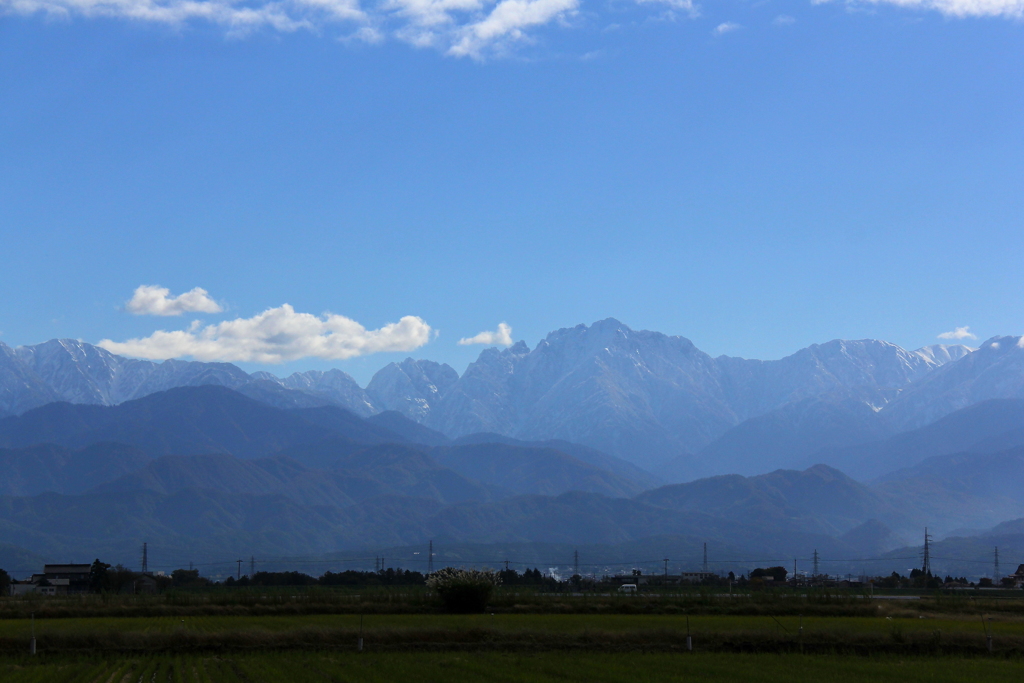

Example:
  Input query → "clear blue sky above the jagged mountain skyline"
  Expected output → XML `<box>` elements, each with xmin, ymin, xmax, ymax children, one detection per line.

<box><xmin>0</xmin><ymin>0</ymin><xmax>1024</xmax><ymax>382</ymax></box>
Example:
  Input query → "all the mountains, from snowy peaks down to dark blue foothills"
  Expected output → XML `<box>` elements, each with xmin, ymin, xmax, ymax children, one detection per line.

<box><xmin>0</xmin><ymin>319</ymin><xmax>1024</xmax><ymax>577</ymax></box>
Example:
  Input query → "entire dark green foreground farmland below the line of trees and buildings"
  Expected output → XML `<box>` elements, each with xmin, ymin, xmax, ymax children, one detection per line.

<box><xmin>0</xmin><ymin>594</ymin><xmax>1024</xmax><ymax>683</ymax></box>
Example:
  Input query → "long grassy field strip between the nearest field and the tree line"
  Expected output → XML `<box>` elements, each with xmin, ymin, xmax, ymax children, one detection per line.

<box><xmin>0</xmin><ymin>613</ymin><xmax>1024</xmax><ymax>657</ymax></box>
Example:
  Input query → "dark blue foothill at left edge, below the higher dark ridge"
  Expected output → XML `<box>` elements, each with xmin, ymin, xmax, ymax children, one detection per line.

<box><xmin>0</xmin><ymin>443</ymin><xmax>152</xmax><ymax>496</ymax></box>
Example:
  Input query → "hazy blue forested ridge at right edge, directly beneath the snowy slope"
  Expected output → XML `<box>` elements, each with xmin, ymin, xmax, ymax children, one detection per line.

<box><xmin>810</xmin><ymin>397</ymin><xmax>1024</xmax><ymax>480</ymax></box>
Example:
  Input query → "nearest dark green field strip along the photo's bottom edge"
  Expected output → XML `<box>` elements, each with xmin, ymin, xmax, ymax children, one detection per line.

<box><xmin>0</xmin><ymin>651</ymin><xmax>1024</xmax><ymax>683</ymax></box>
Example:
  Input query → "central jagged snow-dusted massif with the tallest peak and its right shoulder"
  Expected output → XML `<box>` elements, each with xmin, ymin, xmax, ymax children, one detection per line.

<box><xmin>411</xmin><ymin>318</ymin><xmax>967</xmax><ymax>467</ymax></box>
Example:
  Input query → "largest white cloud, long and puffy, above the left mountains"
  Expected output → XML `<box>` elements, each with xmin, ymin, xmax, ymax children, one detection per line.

<box><xmin>98</xmin><ymin>303</ymin><xmax>430</xmax><ymax>364</ymax></box>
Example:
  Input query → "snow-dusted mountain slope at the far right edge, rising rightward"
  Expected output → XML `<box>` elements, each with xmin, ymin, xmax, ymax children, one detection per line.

<box><xmin>885</xmin><ymin>337</ymin><xmax>1024</xmax><ymax>429</ymax></box>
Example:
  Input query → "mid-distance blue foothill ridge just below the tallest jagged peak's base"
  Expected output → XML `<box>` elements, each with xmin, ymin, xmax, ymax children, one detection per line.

<box><xmin>430</xmin><ymin>443</ymin><xmax>642</xmax><ymax>497</ymax></box>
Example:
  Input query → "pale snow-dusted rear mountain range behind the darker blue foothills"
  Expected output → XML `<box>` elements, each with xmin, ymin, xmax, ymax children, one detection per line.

<box><xmin>0</xmin><ymin>318</ymin><xmax>1003</xmax><ymax>480</ymax></box>
